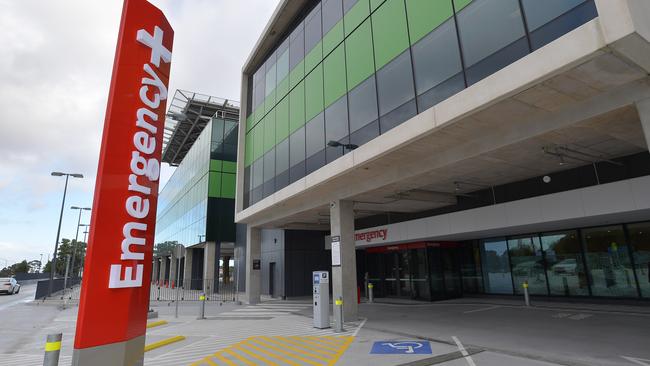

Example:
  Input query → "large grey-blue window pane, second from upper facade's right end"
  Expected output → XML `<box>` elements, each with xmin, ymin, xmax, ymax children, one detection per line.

<box><xmin>458</xmin><ymin>0</ymin><xmax>529</xmax><ymax>84</ymax></box>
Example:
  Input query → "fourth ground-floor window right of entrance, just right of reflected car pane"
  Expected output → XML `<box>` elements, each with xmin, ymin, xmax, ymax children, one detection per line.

<box><xmin>582</xmin><ymin>226</ymin><xmax>638</xmax><ymax>297</ymax></box>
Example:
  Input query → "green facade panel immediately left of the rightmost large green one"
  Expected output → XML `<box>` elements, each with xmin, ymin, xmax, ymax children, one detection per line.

<box><xmin>371</xmin><ymin>0</ymin><xmax>409</xmax><ymax>70</ymax></box>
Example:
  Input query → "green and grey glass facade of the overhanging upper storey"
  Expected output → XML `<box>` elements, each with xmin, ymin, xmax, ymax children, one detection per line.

<box><xmin>243</xmin><ymin>0</ymin><xmax>597</xmax><ymax>207</ymax></box>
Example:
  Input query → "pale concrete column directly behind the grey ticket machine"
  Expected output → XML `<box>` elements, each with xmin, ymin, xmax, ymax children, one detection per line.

<box><xmin>330</xmin><ymin>201</ymin><xmax>358</xmax><ymax>321</ymax></box>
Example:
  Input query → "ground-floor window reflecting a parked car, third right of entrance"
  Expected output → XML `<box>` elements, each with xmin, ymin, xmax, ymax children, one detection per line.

<box><xmin>541</xmin><ymin>231</ymin><xmax>589</xmax><ymax>296</ymax></box>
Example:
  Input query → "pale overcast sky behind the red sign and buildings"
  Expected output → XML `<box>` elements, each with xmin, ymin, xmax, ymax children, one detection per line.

<box><xmin>0</xmin><ymin>0</ymin><xmax>278</xmax><ymax>267</ymax></box>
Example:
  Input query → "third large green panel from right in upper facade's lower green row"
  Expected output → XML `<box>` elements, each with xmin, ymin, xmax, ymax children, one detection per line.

<box><xmin>345</xmin><ymin>19</ymin><xmax>375</xmax><ymax>90</ymax></box>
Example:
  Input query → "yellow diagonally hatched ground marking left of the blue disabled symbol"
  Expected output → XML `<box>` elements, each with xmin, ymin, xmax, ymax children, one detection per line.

<box><xmin>191</xmin><ymin>336</ymin><xmax>354</xmax><ymax>366</ymax></box>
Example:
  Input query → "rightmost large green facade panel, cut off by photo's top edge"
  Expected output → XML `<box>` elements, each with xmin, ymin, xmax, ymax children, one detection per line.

<box><xmin>406</xmin><ymin>0</ymin><xmax>454</xmax><ymax>44</ymax></box>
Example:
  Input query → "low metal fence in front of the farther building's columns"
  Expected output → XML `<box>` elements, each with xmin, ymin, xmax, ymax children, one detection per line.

<box><xmin>150</xmin><ymin>279</ymin><xmax>237</xmax><ymax>302</ymax></box>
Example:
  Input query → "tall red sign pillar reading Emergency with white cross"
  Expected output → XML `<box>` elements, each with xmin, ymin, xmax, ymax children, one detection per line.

<box><xmin>73</xmin><ymin>0</ymin><xmax>174</xmax><ymax>366</ymax></box>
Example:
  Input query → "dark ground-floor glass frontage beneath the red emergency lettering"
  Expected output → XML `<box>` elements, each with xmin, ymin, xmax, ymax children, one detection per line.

<box><xmin>359</xmin><ymin>222</ymin><xmax>650</xmax><ymax>300</ymax></box>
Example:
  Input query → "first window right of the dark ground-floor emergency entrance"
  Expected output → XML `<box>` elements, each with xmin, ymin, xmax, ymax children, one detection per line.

<box><xmin>481</xmin><ymin>239</ymin><xmax>512</xmax><ymax>294</ymax></box>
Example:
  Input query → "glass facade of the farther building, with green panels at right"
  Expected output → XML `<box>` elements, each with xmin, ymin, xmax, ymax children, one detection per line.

<box><xmin>155</xmin><ymin>116</ymin><xmax>239</xmax><ymax>246</ymax></box>
